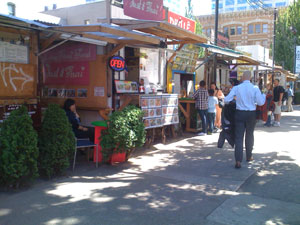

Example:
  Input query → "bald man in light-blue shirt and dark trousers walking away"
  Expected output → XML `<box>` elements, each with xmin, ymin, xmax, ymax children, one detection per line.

<box><xmin>225</xmin><ymin>71</ymin><xmax>266</xmax><ymax>168</ymax></box>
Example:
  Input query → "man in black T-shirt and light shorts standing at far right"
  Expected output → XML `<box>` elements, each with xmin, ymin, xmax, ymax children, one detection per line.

<box><xmin>273</xmin><ymin>79</ymin><xmax>284</xmax><ymax>127</ymax></box>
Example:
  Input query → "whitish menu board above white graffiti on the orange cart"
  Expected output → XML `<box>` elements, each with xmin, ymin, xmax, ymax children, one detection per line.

<box><xmin>0</xmin><ymin>41</ymin><xmax>28</xmax><ymax>64</ymax></box>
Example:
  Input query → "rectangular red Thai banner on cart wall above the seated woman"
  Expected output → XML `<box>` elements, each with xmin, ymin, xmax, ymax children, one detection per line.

<box><xmin>43</xmin><ymin>62</ymin><xmax>90</xmax><ymax>85</ymax></box>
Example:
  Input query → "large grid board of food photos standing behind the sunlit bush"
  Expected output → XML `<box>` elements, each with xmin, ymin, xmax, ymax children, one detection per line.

<box><xmin>140</xmin><ymin>94</ymin><xmax>179</xmax><ymax>129</ymax></box>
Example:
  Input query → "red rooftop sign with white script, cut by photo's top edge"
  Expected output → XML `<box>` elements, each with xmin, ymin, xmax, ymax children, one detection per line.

<box><xmin>123</xmin><ymin>0</ymin><xmax>164</xmax><ymax>20</ymax></box>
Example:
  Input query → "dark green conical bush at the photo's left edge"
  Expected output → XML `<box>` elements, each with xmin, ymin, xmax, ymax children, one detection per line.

<box><xmin>0</xmin><ymin>106</ymin><xmax>39</xmax><ymax>188</ymax></box>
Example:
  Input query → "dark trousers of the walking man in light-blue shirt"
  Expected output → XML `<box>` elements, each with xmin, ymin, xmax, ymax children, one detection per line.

<box><xmin>235</xmin><ymin>110</ymin><xmax>256</xmax><ymax>162</ymax></box>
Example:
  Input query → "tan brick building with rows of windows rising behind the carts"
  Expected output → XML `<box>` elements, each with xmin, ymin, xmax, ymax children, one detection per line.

<box><xmin>198</xmin><ymin>10</ymin><xmax>274</xmax><ymax>48</ymax></box>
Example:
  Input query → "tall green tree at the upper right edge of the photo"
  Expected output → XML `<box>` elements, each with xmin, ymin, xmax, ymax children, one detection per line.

<box><xmin>275</xmin><ymin>1</ymin><xmax>300</xmax><ymax>72</ymax></box>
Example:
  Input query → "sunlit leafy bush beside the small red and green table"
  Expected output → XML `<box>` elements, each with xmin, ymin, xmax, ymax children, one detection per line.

<box><xmin>101</xmin><ymin>105</ymin><xmax>146</xmax><ymax>161</ymax></box>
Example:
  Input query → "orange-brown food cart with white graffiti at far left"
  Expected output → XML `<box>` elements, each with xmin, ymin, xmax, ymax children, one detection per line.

<box><xmin>0</xmin><ymin>15</ymin><xmax>44</xmax><ymax>127</ymax></box>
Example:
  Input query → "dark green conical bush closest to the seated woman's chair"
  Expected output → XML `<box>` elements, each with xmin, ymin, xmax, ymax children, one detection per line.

<box><xmin>39</xmin><ymin>104</ymin><xmax>75</xmax><ymax>178</ymax></box>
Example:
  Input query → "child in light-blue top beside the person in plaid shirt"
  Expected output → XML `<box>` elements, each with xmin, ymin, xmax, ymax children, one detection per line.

<box><xmin>207</xmin><ymin>89</ymin><xmax>218</xmax><ymax>134</ymax></box>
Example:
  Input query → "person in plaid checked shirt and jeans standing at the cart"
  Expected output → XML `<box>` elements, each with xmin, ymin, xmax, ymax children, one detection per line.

<box><xmin>193</xmin><ymin>80</ymin><xmax>208</xmax><ymax>136</ymax></box>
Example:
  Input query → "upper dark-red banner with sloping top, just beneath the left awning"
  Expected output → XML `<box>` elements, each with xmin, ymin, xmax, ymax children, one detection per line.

<box><xmin>41</xmin><ymin>42</ymin><xmax>97</xmax><ymax>63</ymax></box>
